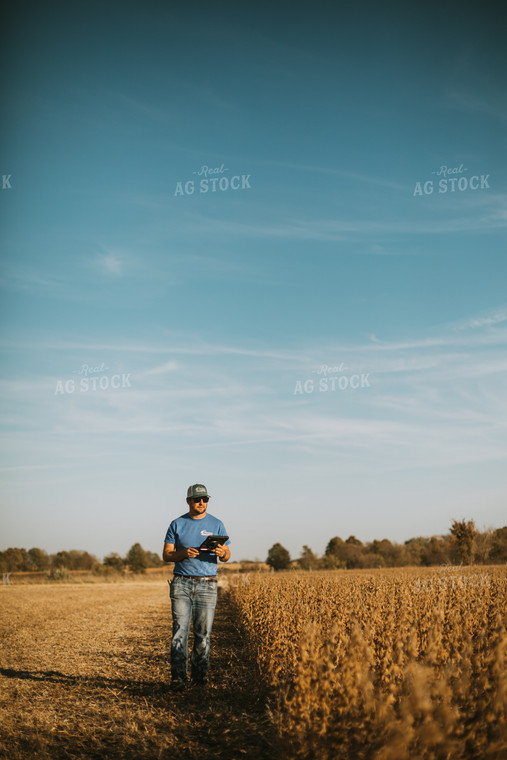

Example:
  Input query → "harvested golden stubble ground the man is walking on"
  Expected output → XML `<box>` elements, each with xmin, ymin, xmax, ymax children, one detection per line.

<box><xmin>0</xmin><ymin>581</ymin><xmax>276</xmax><ymax>760</ymax></box>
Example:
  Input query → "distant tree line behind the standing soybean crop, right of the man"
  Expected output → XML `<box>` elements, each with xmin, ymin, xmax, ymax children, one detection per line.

<box><xmin>266</xmin><ymin>520</ymin><xmax>507</xmax><ymax>570</ymax></box>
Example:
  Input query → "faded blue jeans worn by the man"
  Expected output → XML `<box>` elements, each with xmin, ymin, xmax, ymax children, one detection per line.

<box><xmin>170</xmin><ymin>575</ymin><xmax>217</xmax><ymax>683</ymax></box>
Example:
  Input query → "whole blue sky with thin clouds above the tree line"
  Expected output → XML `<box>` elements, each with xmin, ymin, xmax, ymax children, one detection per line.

<box><xmin>0</xmin><ymin>0</ymin><xmax>507</xmax><ymax>559</ymax></box>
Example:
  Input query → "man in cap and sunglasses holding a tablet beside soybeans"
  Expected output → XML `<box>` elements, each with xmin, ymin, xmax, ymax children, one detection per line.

<box><xmin>162</xmin><ymin>483</ymin><xmax>231</xmax><ymax>691</ymax></box>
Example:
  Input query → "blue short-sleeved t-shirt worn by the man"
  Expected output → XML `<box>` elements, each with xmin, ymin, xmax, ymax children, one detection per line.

<box><xmin>165</xmin><ymin>512</ymin><xmax>231</xmax><ymax>575</ymax></box>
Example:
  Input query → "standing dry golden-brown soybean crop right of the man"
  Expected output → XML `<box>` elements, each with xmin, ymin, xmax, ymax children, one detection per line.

<box><xmin>231</xmin><ymin>567</ymin><xmax>507</xmax><ymax>760</ymax></box>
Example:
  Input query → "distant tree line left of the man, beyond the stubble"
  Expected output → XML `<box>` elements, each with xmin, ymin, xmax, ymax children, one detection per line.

<box><xmin>0</xmin><ymin>543</ymin><xmax>164</xmax><ymax>578</ymax></box>
